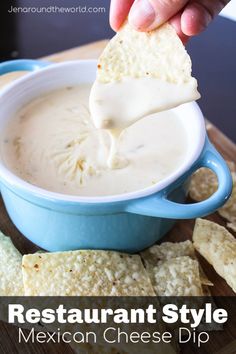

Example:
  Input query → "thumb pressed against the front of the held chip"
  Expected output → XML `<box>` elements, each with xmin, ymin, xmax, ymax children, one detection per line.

<box><xmin>129</xmin><ymin>0</ymin><xmax>188</xmax><ymax>31</ymax></box>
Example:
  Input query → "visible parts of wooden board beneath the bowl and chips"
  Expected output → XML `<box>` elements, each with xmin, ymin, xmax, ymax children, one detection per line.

<box><xmin>0</xmin><ymin>41</ymin><xmax>236</xmax><ymax>354</ymax></box>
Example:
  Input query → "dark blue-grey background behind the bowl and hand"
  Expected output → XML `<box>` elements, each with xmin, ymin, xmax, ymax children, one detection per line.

<box><xmin>0</xmin><ymin>0</ymin><xmax>236</xmax><ymax>142</ymax></box>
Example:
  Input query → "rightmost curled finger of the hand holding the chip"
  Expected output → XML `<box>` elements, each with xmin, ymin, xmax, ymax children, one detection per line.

<box><xmin>181</xmin><ymin>0</ymin><xmax>229</xmax><ymax>36</ymax></box>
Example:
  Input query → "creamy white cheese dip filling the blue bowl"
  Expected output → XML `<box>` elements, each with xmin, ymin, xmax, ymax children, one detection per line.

<box><xmin>1</xmin><ymin>85</ymin><xmax>188</xmax><ymax>196</ymax></box>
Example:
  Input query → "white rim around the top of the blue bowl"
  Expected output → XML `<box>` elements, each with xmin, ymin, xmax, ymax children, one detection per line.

<box><xmin>0</xmin><ymin>59</ymin><xmax>206</xmax><ymax>204</ymax></box>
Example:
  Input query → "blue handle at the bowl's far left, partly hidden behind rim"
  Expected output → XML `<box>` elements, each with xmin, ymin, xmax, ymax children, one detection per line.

<box><xmin>0</xmin><ymin>59</ymin><xmax>51</xmax><ymax>75</ymax></box>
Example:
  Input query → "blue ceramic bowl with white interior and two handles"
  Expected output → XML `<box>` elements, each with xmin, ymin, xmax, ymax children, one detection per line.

<box><xmin>0</xmin><ymin>60</ymin><xmax>232</xmax><ymax>252</ymax></box>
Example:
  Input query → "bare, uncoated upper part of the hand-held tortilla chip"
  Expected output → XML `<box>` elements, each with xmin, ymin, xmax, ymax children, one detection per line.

<box><xmin>97</xmin><ymin>24</ymin><xmax>196</xmax><ymax>84</ymax></box>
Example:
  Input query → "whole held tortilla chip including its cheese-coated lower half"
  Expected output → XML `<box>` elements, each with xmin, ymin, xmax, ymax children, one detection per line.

<box><xmin>90</xmin><ymin>24</ymin><xmax>200</xmax><ymax>129</ymax></box>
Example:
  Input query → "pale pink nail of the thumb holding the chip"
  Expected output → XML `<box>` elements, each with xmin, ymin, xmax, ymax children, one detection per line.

<box><xmin>129</xmin><ymin>0</ymin><xmax>156</xmax><ymax>29</ymax></box>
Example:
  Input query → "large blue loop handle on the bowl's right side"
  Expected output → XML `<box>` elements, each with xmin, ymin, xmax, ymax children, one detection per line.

<box><xmin>126</xmin><ymin>138</ymin><xmax>232</xmax><ymax>219</ymax></box>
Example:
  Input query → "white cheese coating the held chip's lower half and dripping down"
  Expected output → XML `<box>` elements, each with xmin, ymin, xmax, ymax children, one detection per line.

<box><xmin>89</xmin><ymin>77</ymin><xmax>200</xmax><ymax>169</ymax></box>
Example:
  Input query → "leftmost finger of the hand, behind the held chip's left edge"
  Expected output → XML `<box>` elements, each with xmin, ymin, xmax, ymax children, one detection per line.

<box><xmin>110</xmin><ymin>0</ymin><xmax>134</xmax><ymax>31</ymax></box>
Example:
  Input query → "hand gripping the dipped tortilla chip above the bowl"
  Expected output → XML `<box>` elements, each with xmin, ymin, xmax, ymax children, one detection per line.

<box><xmin>110</xmin><ymin>0</ymin><xmax>229</xmax><ymax>41</ymax></box>
